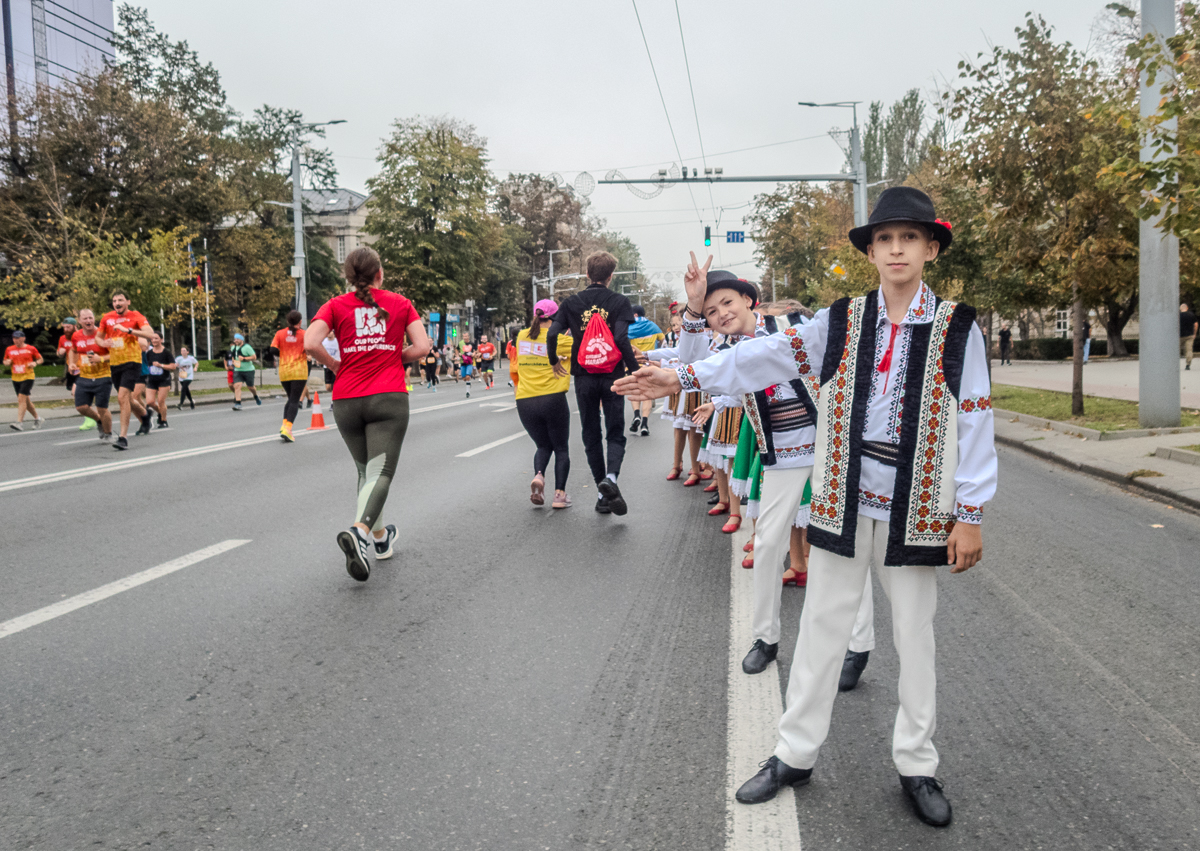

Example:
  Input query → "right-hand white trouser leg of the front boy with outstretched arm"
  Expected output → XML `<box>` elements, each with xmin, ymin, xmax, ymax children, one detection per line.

<box><xmin>880</xmin><ymin>552</ymin><xmax>937</xmax><ymax>777</ymax></box>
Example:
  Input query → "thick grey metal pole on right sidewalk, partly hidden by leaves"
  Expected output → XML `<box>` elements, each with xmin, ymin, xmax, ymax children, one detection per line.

<box><xmin>1138</xmin><ymin>0</ymin><xmax>1180</xmax><ymax>429</ymax></box>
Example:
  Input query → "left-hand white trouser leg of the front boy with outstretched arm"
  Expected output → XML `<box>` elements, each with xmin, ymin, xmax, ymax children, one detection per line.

<box><xmin>772</xmin><ymin>515</ymin><xmax>887</xmax><ymax>768</ymax></box>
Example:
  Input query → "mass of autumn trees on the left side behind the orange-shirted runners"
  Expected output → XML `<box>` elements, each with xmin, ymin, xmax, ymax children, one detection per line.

<box><xmin>0</xmin><ymin>6</ymin><xmax>341</xmax><ymax>355</ymax></box>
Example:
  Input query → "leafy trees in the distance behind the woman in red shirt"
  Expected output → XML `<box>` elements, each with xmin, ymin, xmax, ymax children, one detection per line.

<box><xmin>366</xmin><ymin>116</ymin><xmax>644</xmax><ymax>340</ymax></box>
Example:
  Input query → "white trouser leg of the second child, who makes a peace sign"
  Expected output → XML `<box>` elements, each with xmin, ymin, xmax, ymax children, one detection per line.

<box><xmin>751</xmin><ymin>467</ymin><xmax>812</xmax><ymax>645</ymax></box>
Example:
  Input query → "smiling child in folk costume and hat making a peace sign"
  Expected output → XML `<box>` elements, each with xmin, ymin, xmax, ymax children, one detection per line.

<box><xmin>672</xmin><ymin>265</ymin><xmax>875</xmax><ymax>673</ymax></box>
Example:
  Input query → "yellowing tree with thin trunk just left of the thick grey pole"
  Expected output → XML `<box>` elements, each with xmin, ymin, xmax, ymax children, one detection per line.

<box><xmin>944</xmin><ymin>14</ymin><xmax>1136</xmax><ymax>416</ymax></box>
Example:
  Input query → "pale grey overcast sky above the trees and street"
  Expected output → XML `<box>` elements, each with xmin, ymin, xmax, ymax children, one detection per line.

<box><xmin>134</xmin><ymin>0</ymin><xmax>1105</xmax><ymax>291</ymax></box>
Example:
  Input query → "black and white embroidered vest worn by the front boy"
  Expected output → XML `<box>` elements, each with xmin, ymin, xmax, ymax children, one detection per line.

<box><xmin>809</xmin><ymin>290</ymin><xmax>976</xmax><ymax>565</ymax></box>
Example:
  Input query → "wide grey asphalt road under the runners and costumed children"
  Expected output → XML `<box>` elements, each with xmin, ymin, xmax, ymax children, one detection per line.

<box><xmin>0</xmin><ymin>384</ymin><xmax>1200</xmax><ymax>851</ymax></box>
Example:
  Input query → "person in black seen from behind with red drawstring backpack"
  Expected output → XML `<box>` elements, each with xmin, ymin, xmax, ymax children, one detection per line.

<box><xmin>547</xmin><ymin>251</ymin><xmax>637</xmax><ymax>515</ymax></box>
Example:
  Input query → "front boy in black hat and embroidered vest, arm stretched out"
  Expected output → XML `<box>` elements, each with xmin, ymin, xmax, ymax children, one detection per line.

<box><xmin>619</xmin><ymin>186</ymin><xmax>997</xmax><ymax>827</ymax></box>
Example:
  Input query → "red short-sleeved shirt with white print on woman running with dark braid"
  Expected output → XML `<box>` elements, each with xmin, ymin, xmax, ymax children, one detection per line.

<box><xmin>313</xmin><ymin>287</ymin><xmax>420</xmax><ymax>401</ymax></box>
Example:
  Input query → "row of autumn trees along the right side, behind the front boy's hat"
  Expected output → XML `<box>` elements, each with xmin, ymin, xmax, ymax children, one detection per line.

<box><xmin>752</xmin><ymin>4</ymin><xmax>1200</xmax><ymax>413</ymax></box>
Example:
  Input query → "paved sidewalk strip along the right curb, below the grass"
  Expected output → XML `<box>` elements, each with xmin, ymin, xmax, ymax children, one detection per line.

<box><xmin>996</xmin><ymin>412</ymin><xmax>1200</xmax><ymax>511</ymax></box>
